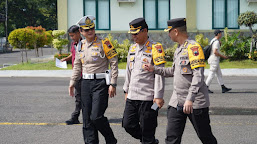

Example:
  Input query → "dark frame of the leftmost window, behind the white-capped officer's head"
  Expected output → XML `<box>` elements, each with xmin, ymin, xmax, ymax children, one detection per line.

<box><xmin>83</xmin><ymin>0</ymin><xmax>111</xmax><ymax>30</ymax></box>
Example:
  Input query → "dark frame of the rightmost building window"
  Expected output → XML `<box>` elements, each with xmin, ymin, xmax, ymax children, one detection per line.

<box><xmin>212</xmin><ymin>0</ymin><xmax>240</xmax><ymax>29</ymax></box>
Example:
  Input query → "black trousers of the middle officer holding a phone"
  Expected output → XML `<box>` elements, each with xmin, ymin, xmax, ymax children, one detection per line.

<box><xmin>122</xmin><ymin>99</ymin><xmax>158</xmax><ymax>144</ymax></box>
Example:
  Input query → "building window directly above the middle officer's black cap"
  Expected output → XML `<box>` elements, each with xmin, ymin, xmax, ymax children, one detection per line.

<box><xmin>143</xmin><ymin>0</ymin><xmax>170</xmax><ymax>30</ymax></box>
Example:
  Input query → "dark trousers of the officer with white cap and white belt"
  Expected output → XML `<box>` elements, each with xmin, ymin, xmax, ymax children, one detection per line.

<box><xmin>81</xmin><ymin>79</ymin><xmax>117</xmax><ymax>144</ymax></box>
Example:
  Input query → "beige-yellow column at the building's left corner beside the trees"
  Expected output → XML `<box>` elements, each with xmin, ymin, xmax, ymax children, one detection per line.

<box><xmin>57</xmin><ymin>0</ymin><xmax>68</xmax><ymax>31</ymax></box>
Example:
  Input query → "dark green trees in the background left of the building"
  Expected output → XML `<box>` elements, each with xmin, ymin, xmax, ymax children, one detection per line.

<box><xmin>0</xmin><ymin>0</ymin><xmax>57</xmax><ymax>36</ymax></box>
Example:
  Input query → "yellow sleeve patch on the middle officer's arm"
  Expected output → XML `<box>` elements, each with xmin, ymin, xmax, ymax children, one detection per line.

<box><xmin>152</xmin><ymin>43</ymin><xmax>166</xmax><ymax>65</ymax></box>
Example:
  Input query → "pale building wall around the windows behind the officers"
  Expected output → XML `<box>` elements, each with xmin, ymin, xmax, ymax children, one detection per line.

<box><xmin>62</xmin><ymin>0</ymin><xmax>257</xmax><ymax>32</ymax></box>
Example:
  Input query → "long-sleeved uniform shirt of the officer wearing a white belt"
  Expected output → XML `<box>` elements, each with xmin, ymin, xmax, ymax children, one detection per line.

<box><xmin>70</xmin><ymin>36</ymin><xmax>118</xmax><ymax>86</ymax></box>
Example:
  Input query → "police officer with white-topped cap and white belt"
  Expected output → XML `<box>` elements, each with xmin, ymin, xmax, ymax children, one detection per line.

<box><xmin>69</xmin><ymin>16</ymin><xmax>118</xmax><ymax>144</ymax></box>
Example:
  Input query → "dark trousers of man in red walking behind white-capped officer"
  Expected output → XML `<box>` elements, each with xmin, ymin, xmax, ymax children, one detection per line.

<box><xmin>71</xmin><ymin>80</ymin><xmax>81</xmax><ymax>120</ymax></box>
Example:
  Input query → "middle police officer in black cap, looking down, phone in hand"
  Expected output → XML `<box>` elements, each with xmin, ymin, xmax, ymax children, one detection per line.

<box><xmin>123</xmin><ymin>18</ymin><xmax>166</xmax><ymax>144</ymax></box>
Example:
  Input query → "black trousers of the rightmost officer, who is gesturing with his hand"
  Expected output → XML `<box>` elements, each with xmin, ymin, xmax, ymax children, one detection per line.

<box><xmin>165</xmin><ymin>106</ymin><xmax>217</xmax><ymax>144</ymax></box>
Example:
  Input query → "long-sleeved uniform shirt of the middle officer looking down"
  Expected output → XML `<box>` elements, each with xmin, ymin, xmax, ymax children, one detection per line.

<box><xmin>123</xmin><ymin>38</ymin><xmax>166</xmax><ymax>101</ymax></box>
